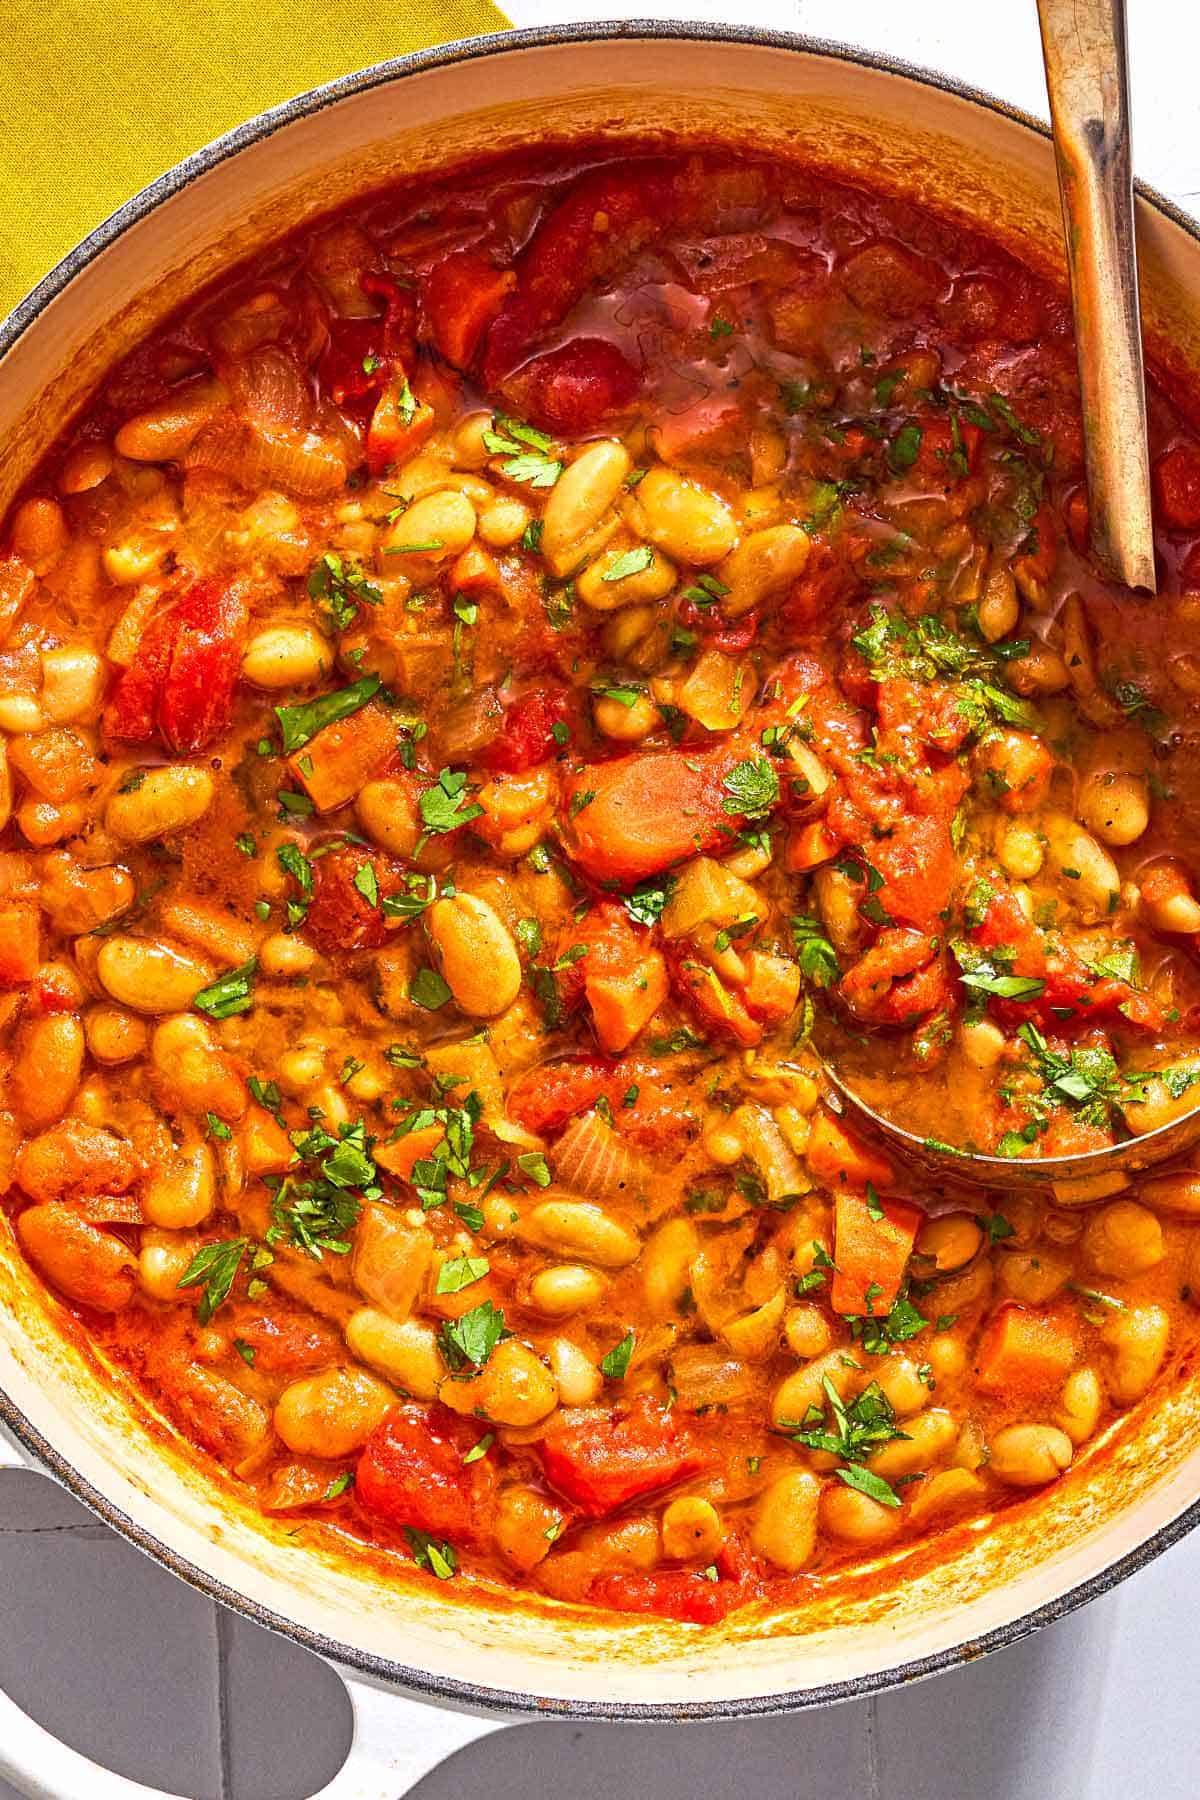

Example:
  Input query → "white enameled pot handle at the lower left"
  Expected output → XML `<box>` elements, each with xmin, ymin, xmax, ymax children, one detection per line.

<box><xmin>0</xmin><ymin>1427</ymin><xmax>518</xmax><ymax>1800</ymax></box>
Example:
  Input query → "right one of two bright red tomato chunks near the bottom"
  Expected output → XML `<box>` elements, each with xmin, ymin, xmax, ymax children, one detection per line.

<box><xmin>540</xmin><ymin>1395</ymin><xmax>703</xmax><ymax>1519</ymax></box>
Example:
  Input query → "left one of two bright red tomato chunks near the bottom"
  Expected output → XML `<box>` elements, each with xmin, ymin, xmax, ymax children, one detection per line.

<box><xmin>354</xmin><ymin>1406</ymin><xmax>495</xmax><ymax>1544</ymax></box>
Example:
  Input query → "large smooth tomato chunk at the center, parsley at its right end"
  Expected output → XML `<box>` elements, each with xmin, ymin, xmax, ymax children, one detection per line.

<box><xmin>563</xmin><ymin>749</ymin><xmax>741</xmax><ymax>882</ymax></box>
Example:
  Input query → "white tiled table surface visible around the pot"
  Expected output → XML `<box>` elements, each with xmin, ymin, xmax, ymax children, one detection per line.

<box><xmin>0</xmin><ymin>0</ymin><xmax>1200</xmax><ymax>1800</ymax></box>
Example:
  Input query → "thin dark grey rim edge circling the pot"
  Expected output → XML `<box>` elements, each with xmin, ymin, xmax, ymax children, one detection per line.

<box><xmin>0</xmin><ymin>18</ymin><xmax>1200</xmax><ymax>1723</ymax></box>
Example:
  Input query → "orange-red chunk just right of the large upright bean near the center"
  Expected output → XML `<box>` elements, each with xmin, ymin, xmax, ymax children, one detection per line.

<box><xmin>554</xmin><ymin>900</ymin><xmax>667</xmax><ymax>1055</ymax></box>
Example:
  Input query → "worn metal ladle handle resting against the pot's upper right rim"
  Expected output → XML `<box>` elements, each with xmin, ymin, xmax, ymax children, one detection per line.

<box><xmin>1038</xmin><ymin>0</ymin><xmax>1155</xmax><ymax>592</ymax></box>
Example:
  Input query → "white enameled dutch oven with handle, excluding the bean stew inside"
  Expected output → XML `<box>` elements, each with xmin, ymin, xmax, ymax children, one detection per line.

<box><xmin>0</xmin><ymin>23</ymin><xmax>1200</xmax><ymax>1800</ymax></box>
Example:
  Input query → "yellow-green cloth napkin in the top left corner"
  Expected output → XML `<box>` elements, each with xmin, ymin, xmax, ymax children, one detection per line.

<box><xmin>0</xmin><ymin>0</ymin><xmax>507</xmax><ymax>319</ymax></box>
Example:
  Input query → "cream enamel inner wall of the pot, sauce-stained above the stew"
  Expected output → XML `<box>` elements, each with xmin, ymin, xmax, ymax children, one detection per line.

<box><xmin>0</xmin><ymin>27</ymin><xmax>1200</xmax><ymax>1710</ymax></box>
